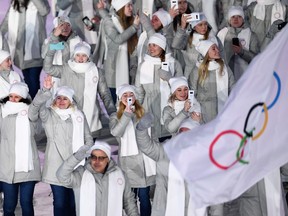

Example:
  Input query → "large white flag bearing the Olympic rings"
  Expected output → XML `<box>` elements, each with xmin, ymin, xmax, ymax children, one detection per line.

<box><xmin>164</xmin><ymin>25</ymin><xmax>288</xmax><ymax>208</ymax></box>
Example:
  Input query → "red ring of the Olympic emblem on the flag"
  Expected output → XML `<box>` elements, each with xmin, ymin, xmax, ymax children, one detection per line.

<box><xmin>209</xmin><ymin>130</ymin><xmax>247</xmax><ymax>170</ymax></box>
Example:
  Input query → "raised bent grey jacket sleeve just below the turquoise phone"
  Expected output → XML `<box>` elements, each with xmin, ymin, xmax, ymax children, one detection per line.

<box><xmin>43</xmin><ymin>49</ymin><xmax>64</xmax><ymax>78</ymax></box>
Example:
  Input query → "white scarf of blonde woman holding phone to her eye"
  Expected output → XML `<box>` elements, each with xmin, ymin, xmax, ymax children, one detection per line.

<box><xmin>120</xmin><ymin>120</ymin><xmax>156</xmax><ymax>176</ymax></box>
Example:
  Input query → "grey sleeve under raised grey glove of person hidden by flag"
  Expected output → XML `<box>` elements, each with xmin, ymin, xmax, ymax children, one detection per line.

<box><xmin>135</xmin><ymin>129</ymin><xmax>167</xmax><ymax>162</ymax></box>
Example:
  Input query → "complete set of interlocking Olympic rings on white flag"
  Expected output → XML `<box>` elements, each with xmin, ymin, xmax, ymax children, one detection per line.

<box><xmin>209</xmin><ymin>71</ymin><xmax>281</xmax><ymax>170</ymax></box>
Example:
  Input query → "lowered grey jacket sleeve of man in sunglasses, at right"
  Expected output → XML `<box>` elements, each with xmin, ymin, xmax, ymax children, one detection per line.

<box><xmin>123</xmin><ymin>172</ymin><xmax>139</xmax><ymax>216</ymax></box>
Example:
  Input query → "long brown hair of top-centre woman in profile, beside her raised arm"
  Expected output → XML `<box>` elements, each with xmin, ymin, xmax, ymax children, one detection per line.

<box><xmin>117</xmin><ymin>6</ymin><xmax>138</xmax><ymax>55</ymax></box>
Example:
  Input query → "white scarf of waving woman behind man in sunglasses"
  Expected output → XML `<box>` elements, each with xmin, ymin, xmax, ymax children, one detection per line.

<box><xmin>52</xmin><ymin>106</ymin><xmax>85</xmax><ymax>165</ymax></box>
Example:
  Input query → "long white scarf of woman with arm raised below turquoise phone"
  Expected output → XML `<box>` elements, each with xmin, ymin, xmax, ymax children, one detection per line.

<box><xmin>68</xmin><ymin>60</ymin><xmax>102</xmax><ymax>131</ymax></box>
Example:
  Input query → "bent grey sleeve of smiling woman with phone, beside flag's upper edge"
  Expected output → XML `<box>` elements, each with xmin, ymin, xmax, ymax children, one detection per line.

<box><xmin>163</xmin><ymin>106</ymin><xmax>189</xmax><ymax>133</ymax></box>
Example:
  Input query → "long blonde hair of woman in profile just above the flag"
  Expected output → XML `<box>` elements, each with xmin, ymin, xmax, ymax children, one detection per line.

<box><xmin>198</xmin><ymin>53</ymin><xmax>224</xmax><ymax>86</ymax></box>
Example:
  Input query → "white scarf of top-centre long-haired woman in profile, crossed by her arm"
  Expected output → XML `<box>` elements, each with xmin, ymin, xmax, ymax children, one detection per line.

<box><xmin>112</xmin><ymin>15</ymin><xmax>129</xmax><ymax>88</ymax></box>
